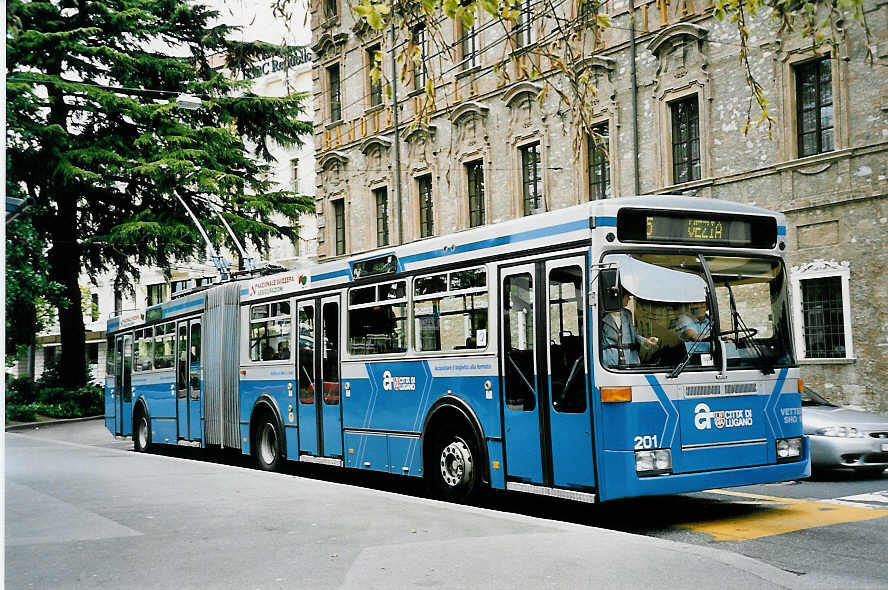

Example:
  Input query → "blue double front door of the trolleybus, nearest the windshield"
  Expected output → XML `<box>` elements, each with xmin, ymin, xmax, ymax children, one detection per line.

<box><xmin>501</xmin><ymin>256</ymin><xmax>595</xmax><ymax>489</ymax></box>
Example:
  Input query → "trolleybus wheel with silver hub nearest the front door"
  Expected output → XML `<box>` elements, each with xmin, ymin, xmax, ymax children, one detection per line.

<box><xmin>425</xmin><ymin>431</ymin><xmax>479</xmax><ymax>502</ymax></box>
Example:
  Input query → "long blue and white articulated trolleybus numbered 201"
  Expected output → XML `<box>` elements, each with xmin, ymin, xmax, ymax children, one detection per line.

<box><xmin>106</xmin><ymin>196</ymin><xmax>810</xmax><ymax>501</ymax></box>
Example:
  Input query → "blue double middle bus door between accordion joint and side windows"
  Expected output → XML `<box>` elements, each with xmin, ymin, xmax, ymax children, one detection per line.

<box><xmin>296</xmin><ymin>296</ymin><xmax>342</xmax><ymax>459</ymax></box>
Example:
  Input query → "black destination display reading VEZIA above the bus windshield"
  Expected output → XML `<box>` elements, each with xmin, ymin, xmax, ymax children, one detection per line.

<box><xmin>617</xmin><ymin>210</ymin><xmax>777</xmax><ymax>248</ymax></box>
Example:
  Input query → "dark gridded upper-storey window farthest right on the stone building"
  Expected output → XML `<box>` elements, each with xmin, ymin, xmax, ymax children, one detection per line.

<box><xmin>795</xmin><ymin>57</ymin><xmax>835</xmax><ymax>158</ymax></box>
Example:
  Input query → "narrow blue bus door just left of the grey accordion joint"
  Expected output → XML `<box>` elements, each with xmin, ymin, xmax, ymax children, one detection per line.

<box><xmin>176</xmin><ymin>319</ymin><xmax>201</xmax><ymax>440</ymax></box>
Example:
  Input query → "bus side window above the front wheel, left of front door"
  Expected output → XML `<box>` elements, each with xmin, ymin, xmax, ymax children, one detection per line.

<box><xmin>413</xmin><ymin>268</ymin><xmax>488</xmax><ymax>352</ymax></box>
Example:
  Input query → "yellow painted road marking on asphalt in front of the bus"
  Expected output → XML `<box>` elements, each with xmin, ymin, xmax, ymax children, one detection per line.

<box><xmin>678</xmin><ymin>490</ymin><xmax>888</xmax><ymax>541</ymax></box>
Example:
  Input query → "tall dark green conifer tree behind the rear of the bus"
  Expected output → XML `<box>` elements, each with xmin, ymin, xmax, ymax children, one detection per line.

<box><xmin>6</xmin><ymin>0</ymin><xmax>313</xmax><ymax>386</ymax></box>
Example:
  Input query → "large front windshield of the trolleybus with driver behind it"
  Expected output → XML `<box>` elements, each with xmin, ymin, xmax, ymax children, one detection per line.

<box><xmin>599</xmin><ymin>253</ymin><xmax>794</xmax><ymax>373</ymax></box>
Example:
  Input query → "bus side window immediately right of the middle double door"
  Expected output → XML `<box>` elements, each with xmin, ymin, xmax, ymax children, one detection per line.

<box><xmin>348</xmin><ymin>281</ymin><xmax>407</xmax><ymax>354</ymax></box>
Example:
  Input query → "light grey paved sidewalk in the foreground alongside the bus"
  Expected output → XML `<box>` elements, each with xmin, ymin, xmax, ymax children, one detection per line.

<box><xmin>5</xmin><ymin>422</ymin><xmax>813</xmax><ymax>590</ymax></box>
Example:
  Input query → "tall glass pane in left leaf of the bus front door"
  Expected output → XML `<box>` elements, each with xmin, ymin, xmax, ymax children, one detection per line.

<box><xmin>503</xmin><ymin>273</ymin><xmax>536</xmax><ymax>412</ymax></box>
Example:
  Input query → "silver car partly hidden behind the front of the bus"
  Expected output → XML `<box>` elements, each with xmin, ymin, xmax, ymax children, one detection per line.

<box><xmin>802</xmin><ymin>387</ymin><xmax>888</xmax><ymax>475</ymax></box>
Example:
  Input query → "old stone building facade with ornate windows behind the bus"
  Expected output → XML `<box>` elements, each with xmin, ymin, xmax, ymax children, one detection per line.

<box><xmin>312</xmin><ymin>0</ymin><xmax>888</xmax><ymax>412</ymax></box>
